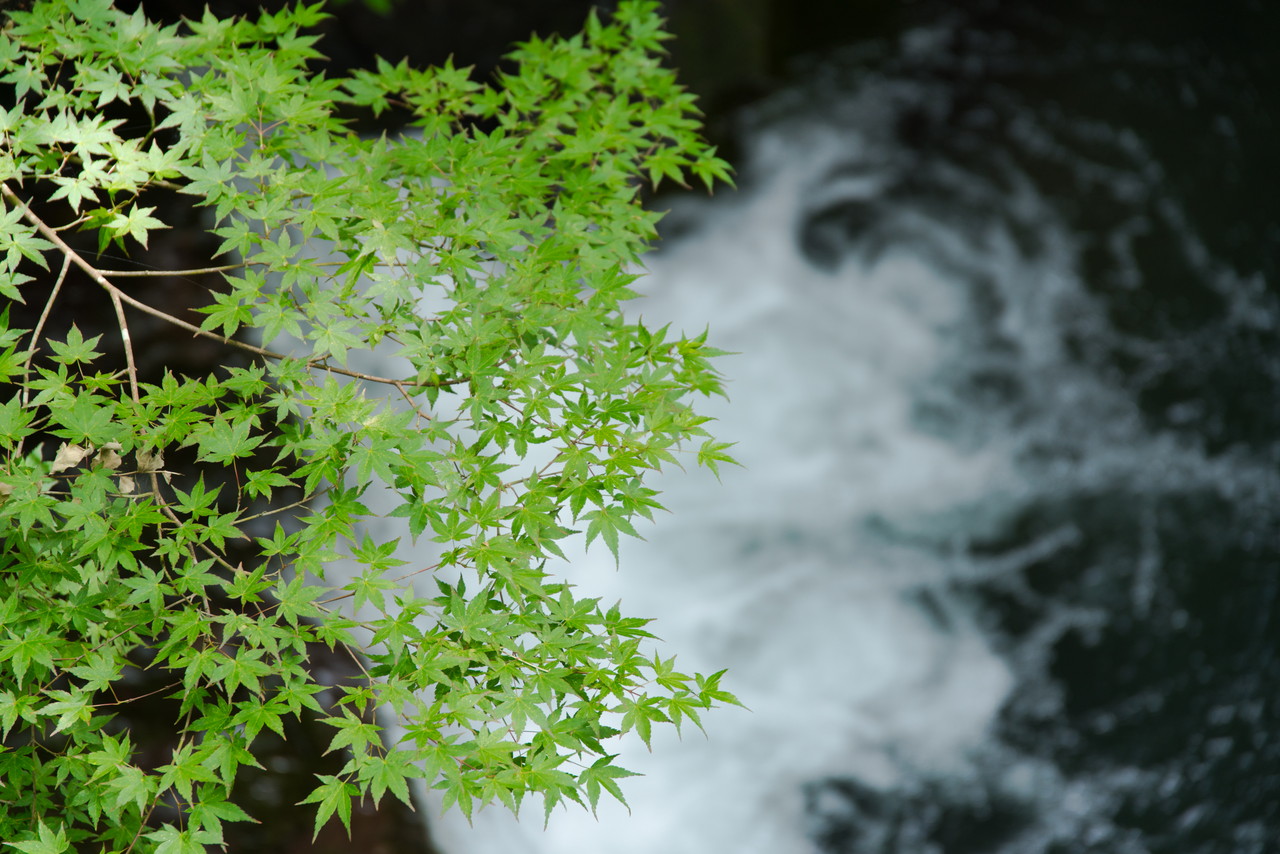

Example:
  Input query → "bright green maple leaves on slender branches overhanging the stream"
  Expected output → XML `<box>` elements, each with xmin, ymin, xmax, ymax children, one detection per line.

<box><xmin>0</xmin><ymin>0</ymin><xmax>732</xmax><ymax>854</ymax></box>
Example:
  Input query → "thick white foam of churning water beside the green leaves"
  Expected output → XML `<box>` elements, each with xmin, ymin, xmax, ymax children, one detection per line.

<box><xmin>435</xmin><ymin>115</ymin><xmax>1049</xmax><ymax>854</ymax></box>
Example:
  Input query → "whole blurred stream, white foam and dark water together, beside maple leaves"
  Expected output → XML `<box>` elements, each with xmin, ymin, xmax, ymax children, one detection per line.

<box><xmin>407</xmin><ymin>8</ymin><xmax>1280</xmax><ymax>854</ymax></box>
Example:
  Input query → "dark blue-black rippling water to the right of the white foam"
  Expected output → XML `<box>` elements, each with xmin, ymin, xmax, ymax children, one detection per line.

<box><xmin>778</xmin><ymin>9</ymin><xmax>1280</xmax><ymax>851</ymax></box>
